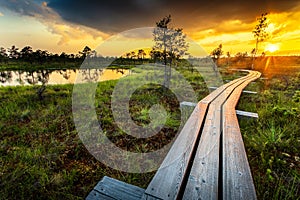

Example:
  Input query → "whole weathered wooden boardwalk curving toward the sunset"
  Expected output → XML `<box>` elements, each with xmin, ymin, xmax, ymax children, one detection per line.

<box><xmin>87</xmin><ymin>71</ymin><xmax>261</xmax><ymax>200</ymax></box>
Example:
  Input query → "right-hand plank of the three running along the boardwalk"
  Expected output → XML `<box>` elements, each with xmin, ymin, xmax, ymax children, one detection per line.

<box><xmin>221</xmin><ymin>72</ymin><xmax>260</xmax><ymax>200</ymax></box>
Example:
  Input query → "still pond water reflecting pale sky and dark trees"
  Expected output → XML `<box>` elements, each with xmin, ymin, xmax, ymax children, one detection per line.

<box><xmin>0</xmin><ymin>69</ymin><xmax>130</xmax><ymax>86</ymax></box>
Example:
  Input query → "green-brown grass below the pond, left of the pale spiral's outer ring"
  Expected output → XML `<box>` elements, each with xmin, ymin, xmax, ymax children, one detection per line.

<box><xmin>0</xmin><ymin>81</ymin><xmax>159</xmax><ymax>199</ymax></box>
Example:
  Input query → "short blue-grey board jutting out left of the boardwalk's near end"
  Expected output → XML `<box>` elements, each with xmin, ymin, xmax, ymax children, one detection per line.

<box><xmin>86</xmin><ymin>176</ymin><xmax>145</xmax><ymax>200</ymax></box>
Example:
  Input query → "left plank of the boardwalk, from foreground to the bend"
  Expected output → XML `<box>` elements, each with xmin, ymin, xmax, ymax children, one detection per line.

<box><xmin>143</xmin><ymin>103</ymin><xmax>208</xmax><ymax>199</ymax></box>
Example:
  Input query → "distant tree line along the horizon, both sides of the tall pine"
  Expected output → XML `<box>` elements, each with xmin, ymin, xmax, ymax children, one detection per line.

<box><xmin>0</xmin><ymin>44</ymin><xmax>300</xmax><ymax>71</ymax></box>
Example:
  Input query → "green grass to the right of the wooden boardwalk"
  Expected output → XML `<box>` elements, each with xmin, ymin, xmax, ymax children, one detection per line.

<box><xmin>238</xmin><ymin>74</ymin><xmax>300</xmax><ymax>199</ymax></box>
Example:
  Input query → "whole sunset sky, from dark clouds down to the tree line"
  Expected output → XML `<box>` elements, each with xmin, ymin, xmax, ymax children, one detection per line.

<box><xmin>0</xmin><ymin>0</ymin><xmax>300</xmax><ymax>55</ymax></box>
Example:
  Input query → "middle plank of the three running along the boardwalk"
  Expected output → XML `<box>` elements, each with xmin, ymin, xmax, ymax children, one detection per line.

<box><xmin>183</xmin><ymin>70</ymin><xmax>253</xmax><ymax>199</ymax></box>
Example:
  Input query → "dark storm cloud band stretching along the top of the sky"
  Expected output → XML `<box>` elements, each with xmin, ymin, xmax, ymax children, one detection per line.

<box><xmin>48</xmin><ymin>0</ymin><xmax>299</xmax><ymax>33</ymax></box>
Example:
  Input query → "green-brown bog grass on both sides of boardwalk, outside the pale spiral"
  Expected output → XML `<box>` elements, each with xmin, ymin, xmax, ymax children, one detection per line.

<box><xmin>0</xmin><ymin>62</ymin><xmax>300</xmax><ymax>199</ymax></box>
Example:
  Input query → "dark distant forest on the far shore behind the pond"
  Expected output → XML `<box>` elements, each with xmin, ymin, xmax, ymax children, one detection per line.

<box><xmin>0</xmin><ymin>45</ymin><xmax>157</xmax><ymax>70</ymax></box>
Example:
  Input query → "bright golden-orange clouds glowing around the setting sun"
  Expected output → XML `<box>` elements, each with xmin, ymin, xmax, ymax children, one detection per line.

<box><xmin>188</xmin><ymin>7</ymin><xmax>300</xmax><ymax>54</ymax></box>
